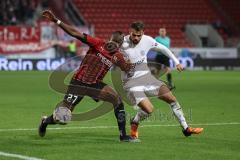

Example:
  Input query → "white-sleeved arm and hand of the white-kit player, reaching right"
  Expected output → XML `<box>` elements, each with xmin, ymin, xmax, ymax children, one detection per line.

<box><xmin>152</xmin><ymin>41</ymin><xmax>183</xmax><ymax>72</ymax></box>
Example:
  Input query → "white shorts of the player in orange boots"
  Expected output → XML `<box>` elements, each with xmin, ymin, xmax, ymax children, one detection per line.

<box><xmin>123</xmin><ymin>73</ymin><xmax>165</xmax><ymax>105</ymax></box>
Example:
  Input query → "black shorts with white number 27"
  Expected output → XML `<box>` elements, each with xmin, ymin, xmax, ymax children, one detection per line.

<box><xmin>64</xmin><ymin>79</ymin><xmax>107</xmax><ymax>109</ymax></box>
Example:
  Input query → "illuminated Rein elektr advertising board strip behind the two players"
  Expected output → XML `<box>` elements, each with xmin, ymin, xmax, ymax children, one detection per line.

<box><xmin>0</xmin><ymin>57</ymin><xmax>240</xmax><ymax>71</ymax></box>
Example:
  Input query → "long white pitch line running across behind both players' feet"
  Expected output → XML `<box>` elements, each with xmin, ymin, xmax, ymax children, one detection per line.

<box><xmin>0</xmin><ymin>122</ymin><xmax>240</xmax><ymax>132</ymax></box>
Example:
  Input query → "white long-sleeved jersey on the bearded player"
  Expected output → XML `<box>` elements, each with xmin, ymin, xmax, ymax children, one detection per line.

<box><xmin>121</xmin><ymin>35</ymin><xmax>179</xmax><ymax>82</ymax></box>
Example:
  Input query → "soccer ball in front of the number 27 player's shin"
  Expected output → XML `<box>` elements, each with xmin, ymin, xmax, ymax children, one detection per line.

<box><xmin>53</xmin><ymin>106</ymin><xmax>72</xmax><ymax>124</ymax></box>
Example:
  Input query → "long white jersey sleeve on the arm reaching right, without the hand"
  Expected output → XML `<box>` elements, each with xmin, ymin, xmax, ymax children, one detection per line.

<box><xmin>149</xmin><ymin>37</ymin><xmax>180</xmax><ymax>65</ymax></box>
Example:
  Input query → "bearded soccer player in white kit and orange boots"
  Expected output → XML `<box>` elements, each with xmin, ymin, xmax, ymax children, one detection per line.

<box><xmin>121</xmin><ymin>22</ymin><xmax>203</xmax><ymax>138</ymax></box>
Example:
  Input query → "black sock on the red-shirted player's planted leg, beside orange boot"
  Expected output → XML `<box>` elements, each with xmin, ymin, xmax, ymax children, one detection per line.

<box><xmin>114</xmin><ymin>103</ymin><xmax>126</xmax><ymax>136</ymax></box>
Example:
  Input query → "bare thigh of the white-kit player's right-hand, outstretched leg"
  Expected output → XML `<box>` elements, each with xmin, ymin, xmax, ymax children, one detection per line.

<box><xmin>158</xmin><ymin>85</ymin><xmax>176</xmax><ymax>103</ymax></box>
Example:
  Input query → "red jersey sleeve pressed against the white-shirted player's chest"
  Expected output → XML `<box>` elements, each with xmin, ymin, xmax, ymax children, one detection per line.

<box><xmin>113</xmin><ymin>52</ymin><xmax>132</xmax><ymax>72</ymax></box>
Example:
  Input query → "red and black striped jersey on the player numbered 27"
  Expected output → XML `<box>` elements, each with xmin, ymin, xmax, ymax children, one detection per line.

<box><xmin>73</xmin><ymin>34</ymin><xmax>131</xmax><ymax>84</ymax></box>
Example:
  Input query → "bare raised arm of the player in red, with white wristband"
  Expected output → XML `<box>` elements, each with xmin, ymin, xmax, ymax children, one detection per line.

<box><xmin>42</xmin><ymin>10</ymin><xmax>84</xmax><ymax>40</ymax></box>
